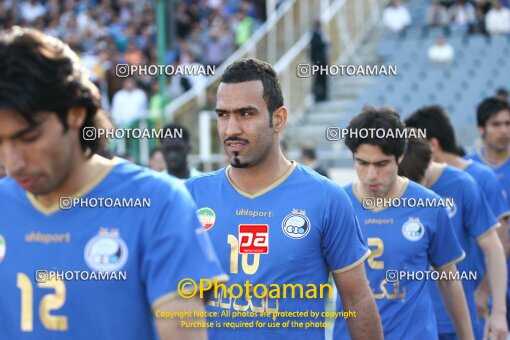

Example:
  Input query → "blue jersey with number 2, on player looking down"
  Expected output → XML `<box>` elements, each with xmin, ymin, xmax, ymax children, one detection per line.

<box><xmin>334</xmin><ymin>179</ymin><xmax>465</xmax><ymax>340</ymax></box>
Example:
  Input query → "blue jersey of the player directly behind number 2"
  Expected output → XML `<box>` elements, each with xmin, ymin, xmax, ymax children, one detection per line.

<box><xmin>429</xmin><ymin>165</ymin><xmax>500</xmax><ymax>334</ymax></box>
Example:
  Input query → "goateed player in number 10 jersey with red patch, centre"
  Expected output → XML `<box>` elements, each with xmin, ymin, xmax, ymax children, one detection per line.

<box><xmin>187</xmin><ymin>59</ymin><xmax>382</xmax><ymax>339</ymax></box>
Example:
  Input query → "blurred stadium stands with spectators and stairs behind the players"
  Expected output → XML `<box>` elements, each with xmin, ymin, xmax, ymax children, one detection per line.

<box><xmin>0</xmin><ymin>0</ymin><xmax>510</xmax><ymax>184</ymax></box>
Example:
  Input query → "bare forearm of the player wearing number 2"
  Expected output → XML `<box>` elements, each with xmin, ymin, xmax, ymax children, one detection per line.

<box><xmin>437</xmin><ymin>264</ymin><xmax>474</xmax><ymax>339</ymax></box>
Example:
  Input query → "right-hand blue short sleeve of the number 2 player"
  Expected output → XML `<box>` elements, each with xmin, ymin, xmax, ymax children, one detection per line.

<box><xmin>428</xmin><ymin>208</ymin><xmax>466</xmax><ymax>269</ymax></box>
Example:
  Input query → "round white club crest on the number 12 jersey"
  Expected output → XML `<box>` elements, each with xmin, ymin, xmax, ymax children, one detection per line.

<box><xmin>85</xmin><ymin>228</ymin><xmax>128</xmax><ymax>272</ymax></box>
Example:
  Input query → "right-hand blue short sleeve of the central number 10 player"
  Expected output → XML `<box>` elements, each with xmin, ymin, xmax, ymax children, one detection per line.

<box><xmin>321</xmin><ymin>185</ymin><xmax>370</xmax><ymax>273</ymax></box>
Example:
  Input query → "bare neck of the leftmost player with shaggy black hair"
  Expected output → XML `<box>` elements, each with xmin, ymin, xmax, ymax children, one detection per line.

<box><xmin>36</xmin><ymin>154</ymin><xmax>112</xmax><ymax>207</ymax></box>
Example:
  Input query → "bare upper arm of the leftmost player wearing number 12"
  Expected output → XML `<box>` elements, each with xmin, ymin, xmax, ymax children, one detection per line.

<box><xmin>155</xmin><ymin>296</ymin><xmax>207</xmax><ymax>340</ymax></box>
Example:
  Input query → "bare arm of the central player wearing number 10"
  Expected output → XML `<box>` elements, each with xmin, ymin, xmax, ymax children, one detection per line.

<box><xmin>333</xmin><ymin>262</ymin><xmax>383</xmax><ymax>339</ymax></box>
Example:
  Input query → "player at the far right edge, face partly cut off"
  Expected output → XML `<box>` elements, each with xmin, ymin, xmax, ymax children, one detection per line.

<box><xmin>465</xmin><ymin>98</ymin><xmax>510</xmax><ymax>326</ymax></box>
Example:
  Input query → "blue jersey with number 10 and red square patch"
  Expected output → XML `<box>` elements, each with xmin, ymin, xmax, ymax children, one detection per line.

<box><xmin>186</xmin><ymin>162</ymin><xmax>370</xmax><ymax>340</ymax></box>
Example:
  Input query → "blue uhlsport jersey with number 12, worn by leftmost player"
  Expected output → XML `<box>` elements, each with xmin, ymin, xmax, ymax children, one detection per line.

<box><xmin>0</xmin><ymin>160</ymin><xmax>224</xmax><ymax>340</ymax></box>
